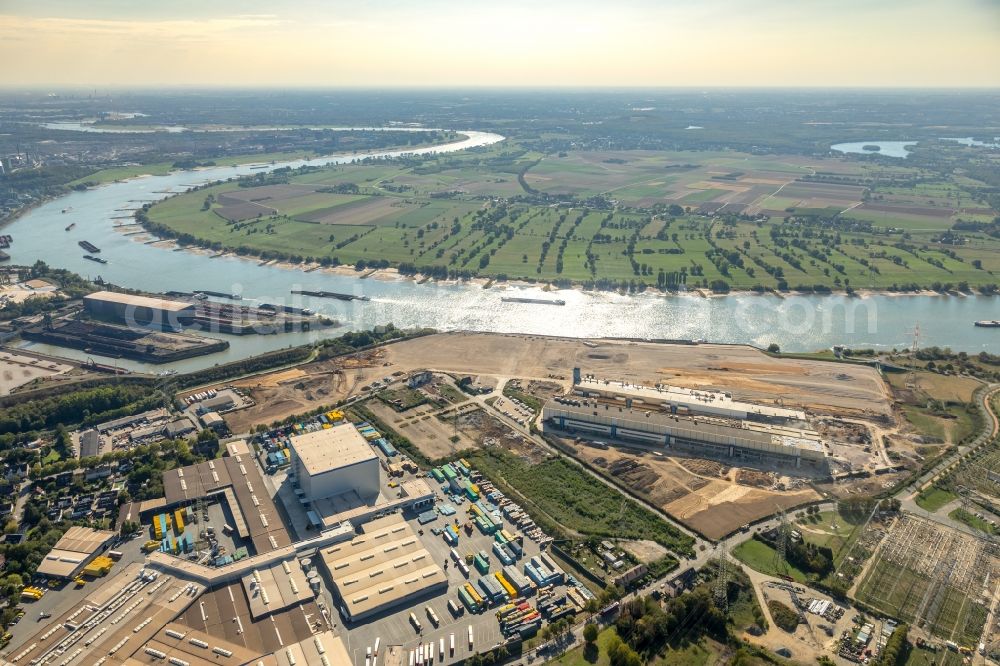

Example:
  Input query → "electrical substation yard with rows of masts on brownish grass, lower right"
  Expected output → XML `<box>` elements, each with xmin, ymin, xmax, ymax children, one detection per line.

<box><xmin>854</xmin><ymin>513</ymin><xmax>1000</xmax><ymax>653</ymax></box>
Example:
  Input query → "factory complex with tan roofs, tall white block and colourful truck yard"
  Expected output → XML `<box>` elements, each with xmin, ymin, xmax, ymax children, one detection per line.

<box><xmin>0</xmin><ymin>410</ymin><xmax>589</xmax><ymax>666</ymax></box>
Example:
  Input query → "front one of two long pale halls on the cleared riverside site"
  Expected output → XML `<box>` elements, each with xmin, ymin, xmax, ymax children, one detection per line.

<box><xmin>542</xmin><ymin>399</ymin><xmax>826</xmax><ymax>472</ymax></box>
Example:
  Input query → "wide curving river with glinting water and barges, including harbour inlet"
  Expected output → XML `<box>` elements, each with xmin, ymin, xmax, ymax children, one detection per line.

<box><xmin>3</xmin><ymin>131</ymin><xmax>1000</xmax><ymax>371</ymax></box>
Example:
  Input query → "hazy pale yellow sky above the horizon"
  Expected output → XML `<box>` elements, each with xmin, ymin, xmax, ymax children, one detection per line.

<box><xmin>0</xmin><ymin>0</ymin><xmax>1000</xmax><ymax>87</ymax></box>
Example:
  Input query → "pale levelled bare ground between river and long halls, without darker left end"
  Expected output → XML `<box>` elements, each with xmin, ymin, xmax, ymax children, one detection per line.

<box><xmin>386</xmin><ymin>333</ymin><xmax>891</xmax><ymax>414</ymax></box>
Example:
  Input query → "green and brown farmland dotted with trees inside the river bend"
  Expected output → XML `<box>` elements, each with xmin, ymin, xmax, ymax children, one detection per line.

<box><xmin>143</xmin><ymin>144</ymin><xmax>1000</xmax><ymax>291</ymax></box>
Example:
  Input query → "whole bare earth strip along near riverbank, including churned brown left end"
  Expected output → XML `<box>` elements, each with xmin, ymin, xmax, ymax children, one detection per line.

<box><xmin>215</xmin><ymin>333</ymin><xmax>890</xmax><ymax>432</ymax></box>
